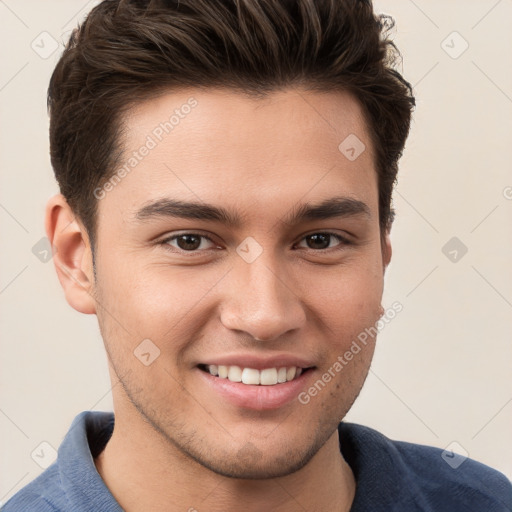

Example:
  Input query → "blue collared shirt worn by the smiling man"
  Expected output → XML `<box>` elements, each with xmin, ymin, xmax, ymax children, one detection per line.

<box><xmin>2</xmin><ymin>411</ymin><xmax>512</xmax><ymax>512</ymax></box>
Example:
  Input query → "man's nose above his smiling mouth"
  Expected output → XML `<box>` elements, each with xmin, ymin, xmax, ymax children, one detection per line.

<box><xmin>220</xmin><ymin>257</ymin><xmax>306</xmax><ymax>341</ymax></box>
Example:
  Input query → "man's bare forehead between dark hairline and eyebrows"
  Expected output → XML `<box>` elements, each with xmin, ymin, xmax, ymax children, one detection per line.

<box><xmin>100</xmin><ymin>89</ymin><xmax>377</xmax><ymax>228</ymax></box>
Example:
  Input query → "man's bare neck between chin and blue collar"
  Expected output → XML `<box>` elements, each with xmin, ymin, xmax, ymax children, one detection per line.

<box><xmin>95</xmin><ymin>412</ymin><xmax>355</xmax><ymax>512</ymax></box>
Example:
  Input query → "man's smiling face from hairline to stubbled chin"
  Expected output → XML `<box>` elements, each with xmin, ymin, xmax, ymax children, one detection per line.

<box><xmin>88</xmin><ymin>89</ymin><xmax>387</xmax><ymax>478</ymax></box>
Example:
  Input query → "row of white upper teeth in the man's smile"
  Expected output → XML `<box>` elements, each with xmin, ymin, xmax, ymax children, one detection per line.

<box><xmin>206</xmin><ymin>364</ymin><xmax>302</xmax><ymax>386</ymax></box>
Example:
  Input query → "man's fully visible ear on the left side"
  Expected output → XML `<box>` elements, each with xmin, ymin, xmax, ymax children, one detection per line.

<box><xmin>45</xmin><ymin>194</ymin><xmax>96</xmax><ymax>315</ymax></box>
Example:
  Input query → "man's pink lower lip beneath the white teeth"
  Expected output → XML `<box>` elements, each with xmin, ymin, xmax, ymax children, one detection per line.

<box><xmin>196</xmin><ymin>368</ymin><xmax>313</xmax><ymax>411</ymax></box>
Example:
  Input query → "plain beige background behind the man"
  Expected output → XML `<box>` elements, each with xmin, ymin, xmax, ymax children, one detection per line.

<box><xmin>0</xmin><ymin>0</ymin><xmax>512</xmax><ymax>502</ymax></box>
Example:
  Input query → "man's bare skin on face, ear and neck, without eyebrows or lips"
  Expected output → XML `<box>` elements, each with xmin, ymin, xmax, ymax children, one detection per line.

<box><xmin>46</xmin><ymin>89</ymin><xmax>391</xmax><ymax>512</ymax></box>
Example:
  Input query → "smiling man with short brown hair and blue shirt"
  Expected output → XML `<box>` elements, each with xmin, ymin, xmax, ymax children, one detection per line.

<box><xmin>4</xmin><ymin>0</ymin><xmax>512</xmax><ymax>512</ymax></box>
